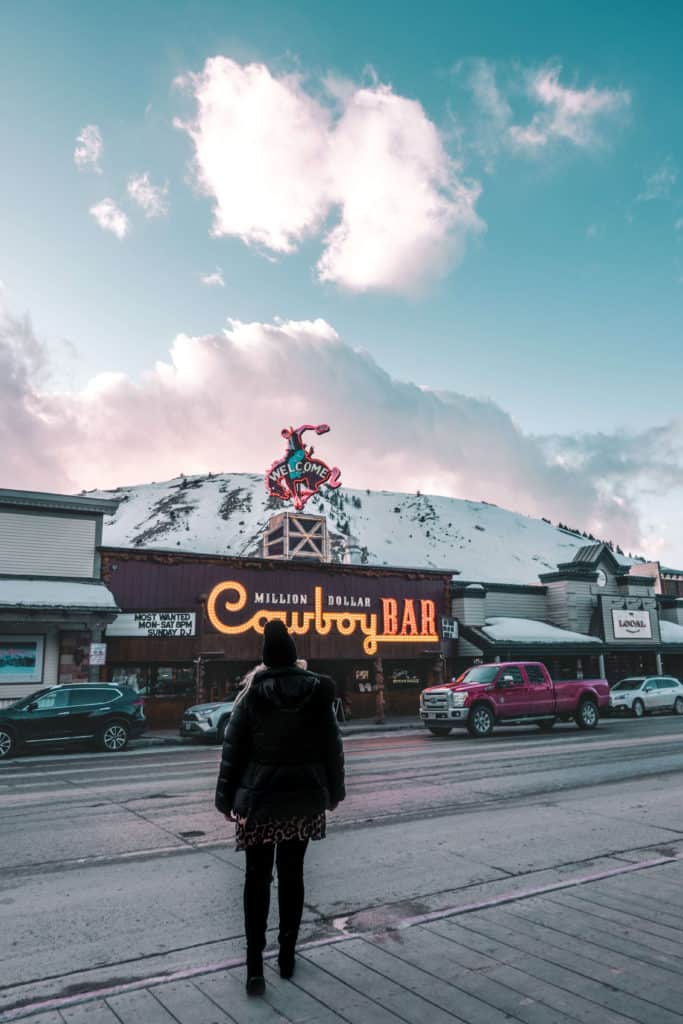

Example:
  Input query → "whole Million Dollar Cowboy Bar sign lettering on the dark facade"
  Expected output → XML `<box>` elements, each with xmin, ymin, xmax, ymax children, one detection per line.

<box><xmin>207</xmin><ymin>580</ymin><xmax>439</xmax><ymax>654</ymax></box>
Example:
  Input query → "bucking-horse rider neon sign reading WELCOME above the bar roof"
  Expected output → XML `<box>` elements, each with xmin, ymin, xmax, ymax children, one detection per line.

<box><xmin>265</xmin><ymin>423</ymin><xmax>341</xmax><ymax>512</ymax></box>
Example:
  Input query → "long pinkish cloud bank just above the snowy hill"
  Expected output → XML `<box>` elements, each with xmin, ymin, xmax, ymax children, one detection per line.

<box><xmin>0</xmin><ymin>303</ymin><xmax>683</xmax><ymax>563</ymax></box>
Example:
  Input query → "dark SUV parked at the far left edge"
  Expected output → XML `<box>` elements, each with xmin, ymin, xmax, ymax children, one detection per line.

<box><xmin>0</xmin><ymin>683</ymin><xmax>146</xmax><ymax>758</ymax></box>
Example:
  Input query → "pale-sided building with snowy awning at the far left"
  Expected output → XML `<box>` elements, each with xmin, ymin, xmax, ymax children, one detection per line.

<box><xmin>0</xmin><ymin>488</ymin><xmax>119</xmax><ymax>707</ymax></box>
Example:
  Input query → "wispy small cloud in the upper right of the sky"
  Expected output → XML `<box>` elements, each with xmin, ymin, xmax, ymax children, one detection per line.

<box><xmin>509</xmin><ymin>66</ymin><xmax>631</xmax><ymax>152</ymax></box>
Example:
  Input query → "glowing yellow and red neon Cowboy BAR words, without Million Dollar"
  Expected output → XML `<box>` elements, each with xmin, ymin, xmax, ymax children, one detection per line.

<box><xmin>207</xmin><ymin>580</ymin><xmax>439</xmax><ymax>654</ymax></box>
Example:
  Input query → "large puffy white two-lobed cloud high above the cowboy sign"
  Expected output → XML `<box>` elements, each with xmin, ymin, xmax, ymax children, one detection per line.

<box><xmin>176</xmin><ymin>57</ymin><xmax>482</xmax><ymax>292</ymax></box>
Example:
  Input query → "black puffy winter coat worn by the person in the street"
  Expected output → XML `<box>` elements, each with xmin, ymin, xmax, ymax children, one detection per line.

<box><xmin>216</xmin><ymin>666</ymin><xmax>346</xmax><ymax>822</ymax></box>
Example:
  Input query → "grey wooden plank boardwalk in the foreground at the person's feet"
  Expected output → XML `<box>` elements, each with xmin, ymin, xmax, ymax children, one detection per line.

<box><xmin>7</xmin><ymin>860</ymin><xmax>683</xmax><ymax>1024</ymax></box>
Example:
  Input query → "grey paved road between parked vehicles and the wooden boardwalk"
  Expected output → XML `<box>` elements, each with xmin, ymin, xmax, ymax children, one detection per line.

<box><xmin>0</xmin><ymin>718</ymin><xmax>683</xmax><ymax>1011</ymax></box>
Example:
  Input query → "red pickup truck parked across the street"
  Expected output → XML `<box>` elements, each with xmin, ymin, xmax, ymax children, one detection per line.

<box><xmin>420</xmin><ymin>662</ymin><xmax>609</xmax><ymax>736</ymax></box>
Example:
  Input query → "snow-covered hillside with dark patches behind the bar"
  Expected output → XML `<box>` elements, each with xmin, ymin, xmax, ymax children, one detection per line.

<box><xmin>90</xmin><ymin>473</ymin><xmax>610</xmax><ymax>584</ymax></box>
